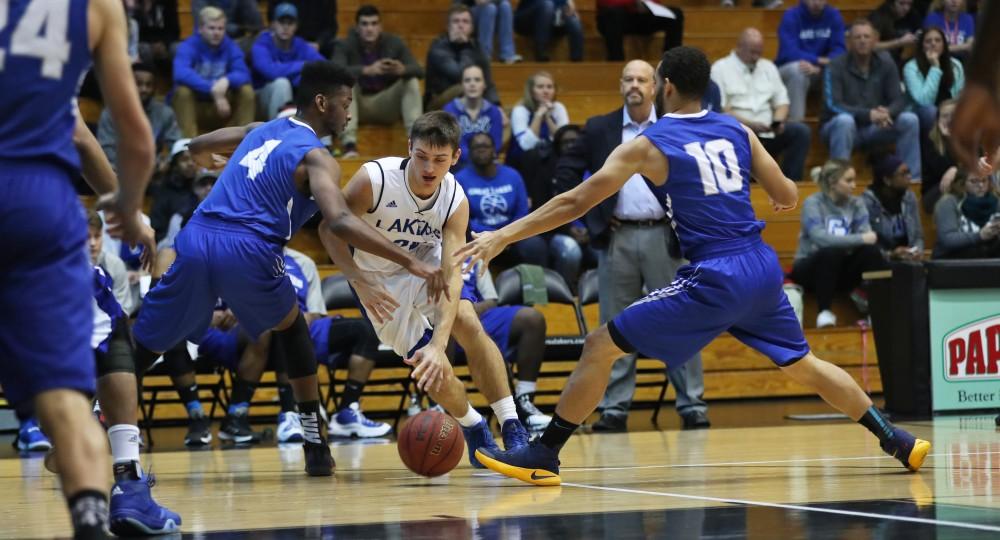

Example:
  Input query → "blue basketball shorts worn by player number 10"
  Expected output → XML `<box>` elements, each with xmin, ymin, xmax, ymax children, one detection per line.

<box><xmin>608</xmin><ymin>242</ymin><xmax>809</xmax><ymax>368</ymax></box>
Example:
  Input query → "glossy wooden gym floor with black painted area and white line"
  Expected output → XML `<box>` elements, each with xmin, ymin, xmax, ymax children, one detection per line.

<box><xmin>0</xmin><ymin>400</ymin><xmax>1000</xmax><ymax>540</ymax></box>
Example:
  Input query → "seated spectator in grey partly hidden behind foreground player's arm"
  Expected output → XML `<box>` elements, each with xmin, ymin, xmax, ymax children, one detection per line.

<box><xmin>97</xmin><ymin>64</ymin><xmax>181</xmax><ymax>175</ymax></box>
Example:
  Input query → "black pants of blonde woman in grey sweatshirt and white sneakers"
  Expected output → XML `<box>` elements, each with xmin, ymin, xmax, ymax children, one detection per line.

<box><xmin>789</xmin><ymin>245</ymin><xmax>889</xmax><ymax>311</ymax></box>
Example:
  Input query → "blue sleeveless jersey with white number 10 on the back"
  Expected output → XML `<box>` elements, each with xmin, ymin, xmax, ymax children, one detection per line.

<box><xmin>642</xmin><ymin>111</ymin><xmax>764</xmax><ymax>260</ymax></box>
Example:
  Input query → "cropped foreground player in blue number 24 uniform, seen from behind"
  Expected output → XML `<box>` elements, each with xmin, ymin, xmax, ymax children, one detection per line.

<box><xmin>0</xmin><ymin>0</ymin><xmax>153</xmax><ymax>538</ymax></box>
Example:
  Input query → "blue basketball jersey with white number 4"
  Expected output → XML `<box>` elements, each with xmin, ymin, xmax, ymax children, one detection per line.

<box><xmin>195</xmin><ymin>118</ymin><xmax>323</xmax><ymax>245</ymax></box>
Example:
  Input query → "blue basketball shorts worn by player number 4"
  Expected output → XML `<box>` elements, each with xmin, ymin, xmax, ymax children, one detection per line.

<box><xmin>132</xmin><ymin>216</ymin><xmax>296</xmax><ymax>351</ymax></box>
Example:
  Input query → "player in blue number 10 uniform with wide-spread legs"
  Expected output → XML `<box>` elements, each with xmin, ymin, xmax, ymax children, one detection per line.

<box><xmin>458</xmin><ymin>47</ymin><xmax>930</xmax><ymax>485</ymax></box>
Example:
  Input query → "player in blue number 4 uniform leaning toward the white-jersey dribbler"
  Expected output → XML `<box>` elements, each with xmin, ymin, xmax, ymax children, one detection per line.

<box><xmin>133</xmin><ymin>61</ymin><xmax>444</xmax><ymax>476</ymax></box>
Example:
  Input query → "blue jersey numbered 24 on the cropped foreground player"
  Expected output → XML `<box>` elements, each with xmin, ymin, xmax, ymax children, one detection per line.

<box><xmin>0</xmin><ymin>0</ymin><xmax>91</xmax><ymax>176</ymax></box>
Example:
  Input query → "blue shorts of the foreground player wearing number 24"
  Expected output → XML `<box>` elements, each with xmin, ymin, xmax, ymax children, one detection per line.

<box><xmin>0</xmin><ymin>169</ymin><xmax>97</xmax><ymax>405</ymax></box>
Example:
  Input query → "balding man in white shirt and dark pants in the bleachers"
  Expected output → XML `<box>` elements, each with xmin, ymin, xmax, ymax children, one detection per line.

<box><xmin>712</xmin><ymin>28</ymin><xmax>811</xmax><ymax>182</ymax></box>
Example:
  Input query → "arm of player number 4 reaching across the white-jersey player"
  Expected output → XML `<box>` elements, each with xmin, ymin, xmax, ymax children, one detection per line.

<box><xmin>305</xmin><ymin>148</ymin><xmax>445</xmax><ymax>299</ymax></box>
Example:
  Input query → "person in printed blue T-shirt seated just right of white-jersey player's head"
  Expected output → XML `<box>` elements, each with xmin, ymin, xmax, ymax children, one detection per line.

<box><xmin>455</xmin><ymin>132</ymin><xmax>548</xmax><ymax>266</ymax></box>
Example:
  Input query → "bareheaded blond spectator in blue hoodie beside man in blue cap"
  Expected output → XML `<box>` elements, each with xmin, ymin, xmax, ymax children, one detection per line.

<box><xmin>173</xmin><ymin>7</ymin><xmax>256</xmax><ymax>138</ymax></box>
